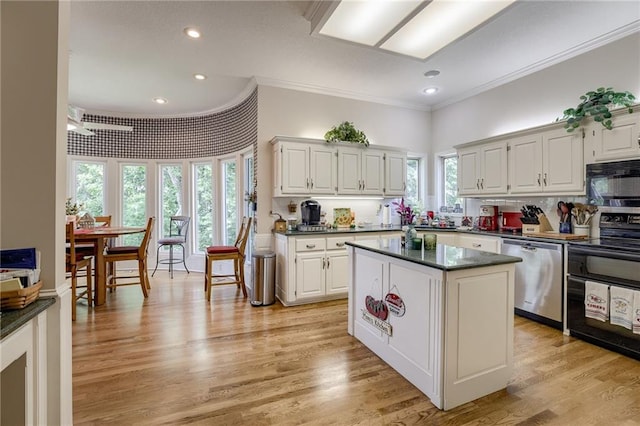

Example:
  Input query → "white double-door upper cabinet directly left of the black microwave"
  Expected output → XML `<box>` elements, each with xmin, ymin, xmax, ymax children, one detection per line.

<box><xmin>509</xmin><ymin>128</ymin><xmax>584</xmax><ymax>195</ymax></box>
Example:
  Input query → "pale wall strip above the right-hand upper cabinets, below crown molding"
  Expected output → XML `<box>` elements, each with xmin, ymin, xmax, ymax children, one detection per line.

<box><xmin>431</xmin><ymin>33</ymin><xmax>640</xmax><ymax>152</ymax></box>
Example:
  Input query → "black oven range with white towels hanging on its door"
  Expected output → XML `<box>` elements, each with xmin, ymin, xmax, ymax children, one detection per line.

<box><xmin>567</xmin><ymin>213</ymin><xmax>640</xmax><ymax>360</ymax></box>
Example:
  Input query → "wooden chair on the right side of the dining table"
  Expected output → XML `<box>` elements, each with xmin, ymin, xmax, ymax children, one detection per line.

<box><xmin>104</xmin><ymin>217</ymin><xmax>155</xmax><ymax>298</ymax></box>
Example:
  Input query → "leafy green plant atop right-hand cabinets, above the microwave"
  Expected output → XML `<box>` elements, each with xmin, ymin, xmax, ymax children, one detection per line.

<box><xmin>562</xmin><ymin>87</ymin><xmax>636</xmax><ymax>132</ymax></box>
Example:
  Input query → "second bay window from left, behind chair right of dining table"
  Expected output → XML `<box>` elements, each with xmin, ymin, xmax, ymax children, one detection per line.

<box><xmin>120</xmin><ymin>164</ymin><xmax>147</xmax><ymax>245</ymax></box>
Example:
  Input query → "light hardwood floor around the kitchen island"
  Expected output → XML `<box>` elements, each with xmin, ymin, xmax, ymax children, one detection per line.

<box><xmin>73</xmin><ymin>271</ymin><xmax>640</xmax><ymax>425</ymax></box>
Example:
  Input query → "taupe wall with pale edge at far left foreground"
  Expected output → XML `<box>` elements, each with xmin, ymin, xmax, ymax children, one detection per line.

<box><xmin>0</xmin><ymin>1</ymin><xmax>73</xmax><ymax>425</ymax></box>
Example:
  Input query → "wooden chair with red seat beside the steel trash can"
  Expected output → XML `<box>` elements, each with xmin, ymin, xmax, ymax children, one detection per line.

<box><xmin>204</xmin><ymin>217</ymin><xmax>252</xmax><ymax>301</ymax></box>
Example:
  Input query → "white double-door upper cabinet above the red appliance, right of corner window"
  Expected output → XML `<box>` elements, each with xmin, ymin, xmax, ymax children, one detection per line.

<box><xmin>458</xmin><ymin>141</ymin><xmax>507</xmax><ymax>195</ymax></box>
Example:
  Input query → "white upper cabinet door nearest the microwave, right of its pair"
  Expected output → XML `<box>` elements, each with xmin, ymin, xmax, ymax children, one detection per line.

<box><xmin>542</xmin><ymin>129</ymin><xmax>584</xmax><ymax>194</ymax></box>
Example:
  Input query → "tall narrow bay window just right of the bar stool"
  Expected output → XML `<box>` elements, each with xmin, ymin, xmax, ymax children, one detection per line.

<box><xmin>192</xmin><ymin>163</ymin><xmax>213</xmax><ymax>253</ymax></box>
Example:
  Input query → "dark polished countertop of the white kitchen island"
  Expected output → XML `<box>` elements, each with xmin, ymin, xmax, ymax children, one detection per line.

<box><xmin>346</xmin><ymin>238</ymin><xmax>522</xmax><ymax>271</ymax></box>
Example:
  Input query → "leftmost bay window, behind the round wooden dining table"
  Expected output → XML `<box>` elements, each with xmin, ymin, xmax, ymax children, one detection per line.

<box><xmin>74</xmin><ymin>161</ymin><xmax>105</xmax><ymax>216</ymax></box>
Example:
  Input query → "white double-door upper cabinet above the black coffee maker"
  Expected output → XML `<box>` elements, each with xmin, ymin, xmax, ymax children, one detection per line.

<box><xmin>273</xmin><ymin>142</ymin><xmax>336</xmax><ymax>197</ymax></box>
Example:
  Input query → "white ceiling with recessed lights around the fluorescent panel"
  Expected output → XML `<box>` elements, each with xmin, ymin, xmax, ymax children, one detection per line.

<box><xmin>69</xmin><ymin>0</ymin><xmax>640</xmax><ymax>117</ymax></box>
